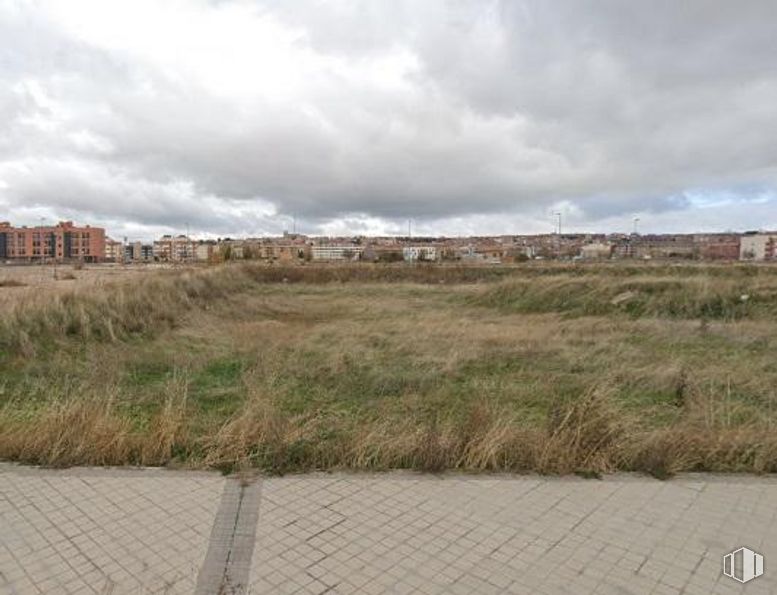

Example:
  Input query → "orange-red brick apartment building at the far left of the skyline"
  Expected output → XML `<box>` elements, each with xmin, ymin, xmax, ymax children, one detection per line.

<box><xmin>0</xmin><ymin>221</ymin><xmax>105</xmax><ymax>262</ymax></box>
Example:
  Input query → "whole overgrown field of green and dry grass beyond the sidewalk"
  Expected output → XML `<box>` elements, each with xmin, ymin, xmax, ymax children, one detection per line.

<box><xmin>0</xmin><ymin>264</ymin><xmax>777</xmax><ymax>476</ymax></box>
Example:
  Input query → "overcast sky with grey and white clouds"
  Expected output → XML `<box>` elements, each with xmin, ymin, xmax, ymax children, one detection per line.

<box><xmin>0</xmin><ymin>0</ymin><xmax>777</xmax><ymax>238</ymax></box>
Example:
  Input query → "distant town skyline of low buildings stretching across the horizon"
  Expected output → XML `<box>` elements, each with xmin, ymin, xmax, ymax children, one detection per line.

<box><xmin>0</xmin><ymin>213</ymin><xmax>756</xmax><ymax>265</ymax></box>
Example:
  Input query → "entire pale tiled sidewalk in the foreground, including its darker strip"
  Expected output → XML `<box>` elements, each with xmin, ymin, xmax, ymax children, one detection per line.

<box><xmin>0</xmin><ymin>465</ymin><xmax>777</xmax><ymax>595</ymax></box>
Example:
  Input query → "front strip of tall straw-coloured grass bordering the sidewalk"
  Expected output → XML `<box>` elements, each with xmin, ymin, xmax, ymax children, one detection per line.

<box><xmin>0</xmin><ymin>374</ymin><xmax>777</xmax><ymax>477</ymax></box>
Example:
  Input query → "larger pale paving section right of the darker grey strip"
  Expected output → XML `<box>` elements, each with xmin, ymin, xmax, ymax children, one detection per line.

<box><xmin>249</xmin><ymin>474</ymin><xmax>777</xmax><ymax>595</ymax></box>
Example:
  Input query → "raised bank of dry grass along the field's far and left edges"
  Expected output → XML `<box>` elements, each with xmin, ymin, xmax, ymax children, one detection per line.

<box><xmin>0</xmin><ymin>263</ymin><xmax>777</xmax><ymax>357</ymax></box>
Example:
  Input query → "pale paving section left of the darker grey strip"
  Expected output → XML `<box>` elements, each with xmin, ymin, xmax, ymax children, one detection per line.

<box><xmin>0</xmin><ymin>465</ymin><xmax>224</xmax><ymax>595</ymax></box>
